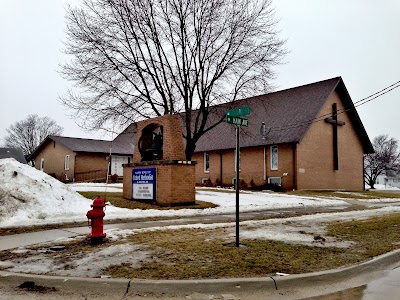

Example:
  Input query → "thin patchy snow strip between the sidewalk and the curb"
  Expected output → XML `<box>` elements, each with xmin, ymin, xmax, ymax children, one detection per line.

<box><xmin>0</xmin><ymin>207</ymin><xmax>400</xmax><ymax>277</ymax></box>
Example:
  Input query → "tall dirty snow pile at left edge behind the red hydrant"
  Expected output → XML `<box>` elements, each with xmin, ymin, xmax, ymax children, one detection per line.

<box><xmin>0</xmin><ymin>158</ymin><xmax>91</xmax><ymax>227</ymax></box>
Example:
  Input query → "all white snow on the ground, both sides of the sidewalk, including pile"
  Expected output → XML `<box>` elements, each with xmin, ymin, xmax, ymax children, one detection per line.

<box><xmin>0</xmin><ymin>159</ymin><xmax>400</xmax><ymax>277</ymax></box>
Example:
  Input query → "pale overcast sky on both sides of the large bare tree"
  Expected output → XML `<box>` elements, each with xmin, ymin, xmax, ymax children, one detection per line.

<box><xmin>0</xmin><ymin>0</ymin><xmax>400</xmax><ymax>143</ymax></box>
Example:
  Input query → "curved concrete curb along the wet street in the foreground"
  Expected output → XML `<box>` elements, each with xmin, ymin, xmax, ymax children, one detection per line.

<box><xmin>0</xmin><ymin>249</ymin><xmax>400</xmax><ymax>299</ymax></box>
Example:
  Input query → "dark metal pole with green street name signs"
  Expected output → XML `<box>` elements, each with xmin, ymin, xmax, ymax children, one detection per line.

<box><xmin>226</xmin><ymin>106</ymin><xmax>250</xmax><ymax>247</ymax></box>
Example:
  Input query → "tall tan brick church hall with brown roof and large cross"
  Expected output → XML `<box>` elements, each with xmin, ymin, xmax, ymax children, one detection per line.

<box><xmin>192</xmin><ymin>77</ymin><xmax>374</xmax><ymax>191</ymax></box>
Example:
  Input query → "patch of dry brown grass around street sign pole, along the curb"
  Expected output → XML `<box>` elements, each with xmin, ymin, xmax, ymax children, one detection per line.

<box><xmin>107</xmin><ymin>214</ymin><xmax>400</xmax><ymax>279</ymax></box>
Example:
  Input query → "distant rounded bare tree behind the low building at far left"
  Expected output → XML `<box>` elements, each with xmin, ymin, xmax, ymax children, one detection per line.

<box><xmin>4</xmin><ymin>115</ymin><xmax>63</xmax><ymax>157</ymax></box>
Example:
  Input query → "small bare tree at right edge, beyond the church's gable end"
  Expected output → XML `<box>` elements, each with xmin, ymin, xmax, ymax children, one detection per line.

<box><xmin>364</xmin><ymin>135</ymin><xmax>400</xmax><ymax>189</ymax></box>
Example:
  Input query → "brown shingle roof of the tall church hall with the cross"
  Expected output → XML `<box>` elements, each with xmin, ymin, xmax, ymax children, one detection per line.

<box><xmin>195</xmin><ymin>77</ymin><xmax>373</xmax><ymax>153</ymax></box>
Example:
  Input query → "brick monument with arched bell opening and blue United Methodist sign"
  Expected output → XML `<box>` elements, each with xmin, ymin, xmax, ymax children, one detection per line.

<box><xmin>123</xmin><ymin>115</ymin><xmax>196</xmax><ymax>206</ymax></box>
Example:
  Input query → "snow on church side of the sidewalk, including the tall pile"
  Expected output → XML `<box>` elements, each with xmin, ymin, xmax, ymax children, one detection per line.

<box><xmin>0</xmin><ymin>158</ymin><xmax>354</xmax><ymax>227</ymax></box>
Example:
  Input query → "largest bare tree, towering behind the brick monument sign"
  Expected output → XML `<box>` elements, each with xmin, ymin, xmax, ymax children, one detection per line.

<box><xmin>61</xmin><ymin>0</ymin><xmax>285</xmax><ymax>159</ymax></box>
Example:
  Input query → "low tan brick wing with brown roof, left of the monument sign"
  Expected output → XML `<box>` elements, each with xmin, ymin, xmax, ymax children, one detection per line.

<box><xmin>31</xmin><ymin>125</ymin><xmax>134</xmax><ymax>182</ymax></box>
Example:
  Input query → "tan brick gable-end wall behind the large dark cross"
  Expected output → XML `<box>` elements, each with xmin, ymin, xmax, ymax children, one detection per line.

<box><xmin>297</xmin><ymin>92</ymin><xmax>364</xmax><ymax>191</ymax></box>
